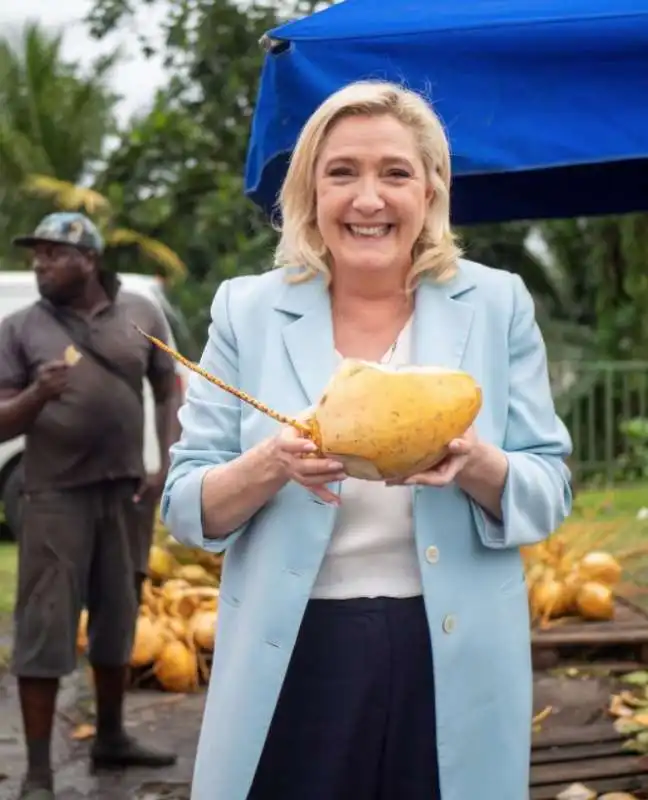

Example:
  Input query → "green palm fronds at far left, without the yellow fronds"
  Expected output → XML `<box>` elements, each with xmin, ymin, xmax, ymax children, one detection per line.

<box><xmin>0</xmin><ymin>23</ymin><xmax>116</xmax><ymax>261</ymax></box>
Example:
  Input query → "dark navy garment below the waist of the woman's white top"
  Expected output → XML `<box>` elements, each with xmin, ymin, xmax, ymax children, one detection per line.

<box><xmin>248</xmin><ymin>597</ymin><xmax>440</xmax><ymax>800</ymax></box>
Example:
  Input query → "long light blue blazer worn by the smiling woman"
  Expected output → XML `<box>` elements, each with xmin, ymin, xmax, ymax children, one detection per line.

<box><xmin>162</xmin><ymin>261</ymin><xmax>571</xmax><ymax>800</ymax></box>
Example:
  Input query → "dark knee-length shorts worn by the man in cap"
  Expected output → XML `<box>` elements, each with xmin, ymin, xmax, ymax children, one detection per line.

<box><xmin>11</xmin><ymin>481</ymin><xmax>142</xmax><ymax>678</ymax></box>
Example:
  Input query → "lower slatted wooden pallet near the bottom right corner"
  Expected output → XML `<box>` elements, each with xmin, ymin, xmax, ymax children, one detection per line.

<box><xmin>530</xmin><ymin>722</ymin><xmax>648</xmax><ymax>800</ymax></box>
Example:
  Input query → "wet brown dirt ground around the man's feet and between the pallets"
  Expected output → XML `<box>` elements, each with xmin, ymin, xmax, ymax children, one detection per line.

<box><xmin>0</xmin><ymin>671</ymin><xmax>614</xmax><ymax>800</ymax></box>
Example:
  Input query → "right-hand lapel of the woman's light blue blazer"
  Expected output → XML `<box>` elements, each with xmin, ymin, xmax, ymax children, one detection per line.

<box><xmin>411</xmin><ymin>268</ymin><xmax>474</xmax><ymax>369</ymax></box>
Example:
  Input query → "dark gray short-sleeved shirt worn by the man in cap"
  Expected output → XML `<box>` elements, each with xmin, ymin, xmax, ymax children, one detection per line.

<box><xmin>0</xmin><ymin>290</ymin><xmax>174</xmax><ymax>492</ymax></box>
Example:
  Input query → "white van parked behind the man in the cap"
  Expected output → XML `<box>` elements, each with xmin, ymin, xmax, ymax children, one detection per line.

<box><xmin>0</xmin><ymin>271</ymin><xmax>187</xmax><ymax>533</ymax></box>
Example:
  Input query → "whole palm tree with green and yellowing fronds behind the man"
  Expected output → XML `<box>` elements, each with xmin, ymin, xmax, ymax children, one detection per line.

<box><xmin>0</xmin><ymin>24</ymin><xmax>185</xmax><ymax>276</ymax></box>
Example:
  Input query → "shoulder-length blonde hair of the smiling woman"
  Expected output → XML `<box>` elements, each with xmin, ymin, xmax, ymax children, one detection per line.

<box><xmin>274</xmin><ymin>81</ymin><xmax>461</xmax><ymax>287</ymax></box>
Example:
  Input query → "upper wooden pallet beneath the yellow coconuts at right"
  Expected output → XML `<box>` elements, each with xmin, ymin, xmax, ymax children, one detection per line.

<box><xmin>531</xmin><ymin>599</ymin><xmax>648</xmax><ymax>671</ymax></box>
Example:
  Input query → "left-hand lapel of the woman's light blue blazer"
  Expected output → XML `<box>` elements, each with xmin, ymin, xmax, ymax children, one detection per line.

<box><xmin>275</xmin><ymin>276</ymin><xmax>337</xmax><ymax>405</ymax></box>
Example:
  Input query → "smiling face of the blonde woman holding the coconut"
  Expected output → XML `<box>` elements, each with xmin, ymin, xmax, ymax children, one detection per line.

<box><xmin>315</xmin><ymin>115</ymin><xmax>432</xmax><ymax>282</ymax></box>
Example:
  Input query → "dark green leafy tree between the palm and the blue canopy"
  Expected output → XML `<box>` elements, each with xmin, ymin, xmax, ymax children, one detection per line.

<box><xmin>85</xmin><ymin>0</ymin><xmax>288</xmax><ymax>342</ymax></box>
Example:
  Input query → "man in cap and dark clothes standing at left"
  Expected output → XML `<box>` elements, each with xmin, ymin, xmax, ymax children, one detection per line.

<box><xmin>0</xmin><ymin>213</ymin><xmax>177</xmax><ymax>800</ymax></box>
